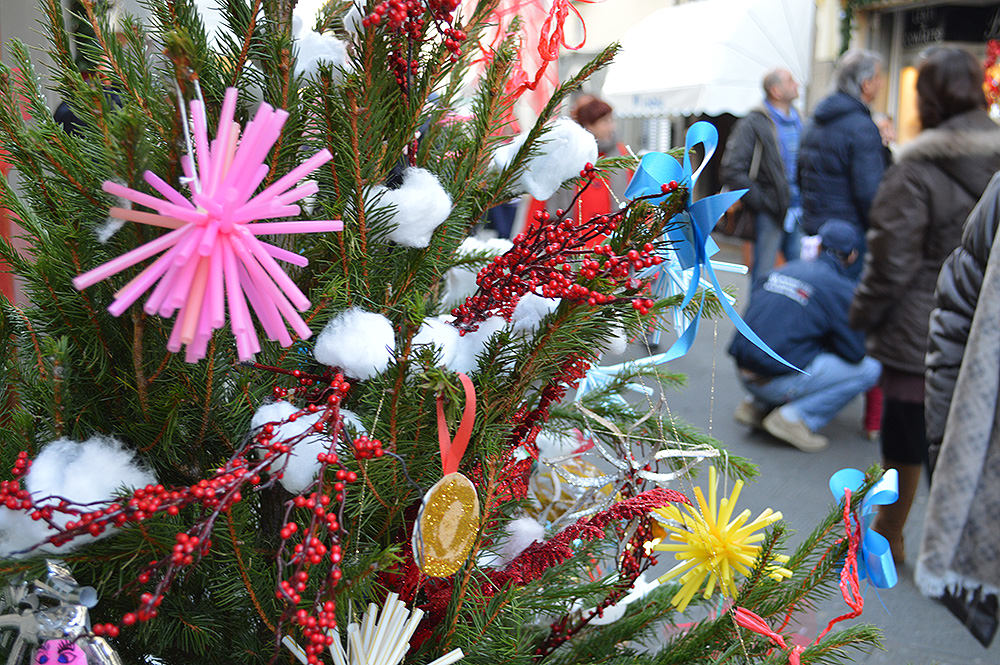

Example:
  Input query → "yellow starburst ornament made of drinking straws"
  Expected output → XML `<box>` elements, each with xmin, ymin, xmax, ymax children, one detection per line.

<box><xmin>653</xmin><ymin>466</ymin><xmax>792</xmax><ymax>612</ymax></box>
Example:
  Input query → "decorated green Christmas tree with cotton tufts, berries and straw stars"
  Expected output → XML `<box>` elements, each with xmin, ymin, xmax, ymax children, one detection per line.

<box><xmin>0</xmin><ymin>0</ymin><xmax>877</xmax><ymax>665</ymax></box>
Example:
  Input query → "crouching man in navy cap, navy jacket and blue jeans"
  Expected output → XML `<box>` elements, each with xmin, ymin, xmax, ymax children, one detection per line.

<box><xmin>729</xmin><ymin>220</ymin><xmax>882</xmax><ymax>452</ymax></box>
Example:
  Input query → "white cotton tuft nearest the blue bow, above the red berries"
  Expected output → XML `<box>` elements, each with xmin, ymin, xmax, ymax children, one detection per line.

<box><xmin>493</xmin><ymin>118</ymin><xmax>597</xmax><ymax>201</ymax></box>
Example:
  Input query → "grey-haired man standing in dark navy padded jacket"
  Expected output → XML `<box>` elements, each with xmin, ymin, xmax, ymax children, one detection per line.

<box><xmin>799</xmin><ymin>50</ymin><xmax>886</xmax><ymax>241</ymax></box>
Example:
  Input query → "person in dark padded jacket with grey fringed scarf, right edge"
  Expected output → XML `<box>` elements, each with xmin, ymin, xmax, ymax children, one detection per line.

<box><xmin>914</xmin><ymin>174</ymin><xmax>1000</xmax><ymax>646</ymax></box>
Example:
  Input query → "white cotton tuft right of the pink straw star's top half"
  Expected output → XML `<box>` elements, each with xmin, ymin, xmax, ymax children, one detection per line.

<box><xmin>371</xmin><ymin>167</ymin><xmax>451</xmax><ymax>247</ymax></box>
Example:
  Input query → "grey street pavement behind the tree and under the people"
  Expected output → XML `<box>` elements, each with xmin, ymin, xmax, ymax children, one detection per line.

<box><xmin>607</xmin><ymin>239</ymin><xmax>1000</xmax><ymax>665</ymax></box>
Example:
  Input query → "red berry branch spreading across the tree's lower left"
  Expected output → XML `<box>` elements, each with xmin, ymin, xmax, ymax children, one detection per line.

<box><xmin>0</xmin><ymin>364</ymin><xmax>382</xmax><ymax>662</ymax></box>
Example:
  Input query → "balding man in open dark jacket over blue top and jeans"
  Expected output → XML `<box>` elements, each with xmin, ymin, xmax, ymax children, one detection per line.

<box><xmin>721</xmin><ymin>69</ymin><xmax>802</xmax><ymax>284</ymax></box>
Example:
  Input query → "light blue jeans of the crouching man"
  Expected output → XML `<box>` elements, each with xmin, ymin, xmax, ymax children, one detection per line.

<box><xmin>743</xmin><ymin>352</ymin><xmax>882</xmax><ymax>432</ymax></box>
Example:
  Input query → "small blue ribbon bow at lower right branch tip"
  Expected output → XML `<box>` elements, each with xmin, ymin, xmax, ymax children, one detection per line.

<box><xmin>830</xmin><ymin>469</ymin><xmax>899</xmax><ymax>589</ymax></box>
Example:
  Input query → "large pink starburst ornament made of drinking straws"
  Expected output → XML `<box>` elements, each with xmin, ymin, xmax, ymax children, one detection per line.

<box><xmin>73</xmin><ymin>88</ymin><xmax>343</xmax><ymax>362</ymax></box>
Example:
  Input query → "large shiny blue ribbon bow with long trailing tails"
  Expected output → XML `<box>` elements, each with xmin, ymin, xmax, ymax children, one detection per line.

<box><xmin>625</xmin><ymin>121</ymin><xmax>802</xmax><ymax>372</ymax></box>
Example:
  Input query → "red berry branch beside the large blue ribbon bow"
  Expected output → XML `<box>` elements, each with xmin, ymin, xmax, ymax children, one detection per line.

<box><xmin>451</xmin><ymin>164</ymin><xmax>678</xmax><ymax>334</ymax></box>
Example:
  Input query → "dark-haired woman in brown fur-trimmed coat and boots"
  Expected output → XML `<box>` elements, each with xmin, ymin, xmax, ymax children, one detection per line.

<box><xmin>850</xmin><ymin>48</ymin><xmax>1000</xmax><ymax>562</ymax></box>
